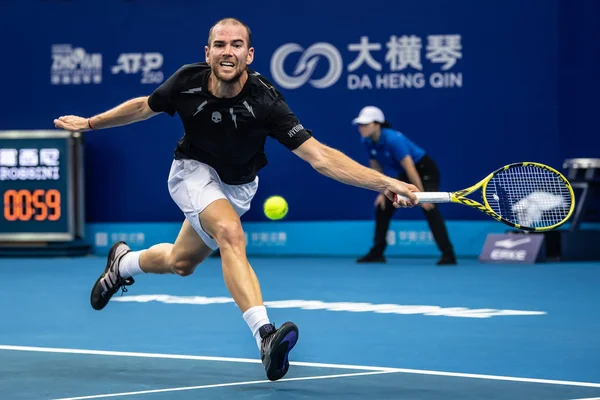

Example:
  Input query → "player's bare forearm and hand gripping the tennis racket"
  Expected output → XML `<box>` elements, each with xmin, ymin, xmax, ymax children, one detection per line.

<box><xmin>294</xmin><ymin>138</ymin><xmax>419</xmax><ymax>207</ymax></box>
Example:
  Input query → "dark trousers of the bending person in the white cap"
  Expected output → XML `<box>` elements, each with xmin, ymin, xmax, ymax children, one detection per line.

<box><xmin>370</xmin><ymin>155</ymin><xmax>454</xmax><ymax>256</ymax></box>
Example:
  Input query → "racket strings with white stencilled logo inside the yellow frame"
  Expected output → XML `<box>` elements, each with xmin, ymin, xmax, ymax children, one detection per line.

<box><xmin>485</xmin><ymin>165</ymin><xmax>573</xmax><ymax>228</ymax></box>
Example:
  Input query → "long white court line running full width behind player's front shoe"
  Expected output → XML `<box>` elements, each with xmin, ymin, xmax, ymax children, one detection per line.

<box><xmin>0</xmin><ymin>345</ymin><xmax>600</xmax><ymax>388</ymax></box>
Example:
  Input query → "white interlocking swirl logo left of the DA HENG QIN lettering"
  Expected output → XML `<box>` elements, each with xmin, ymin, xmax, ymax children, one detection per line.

<box><xmin>271</xmin><ymin>42</ymin><xmax>343</xmax><ymax>89</ymax></box>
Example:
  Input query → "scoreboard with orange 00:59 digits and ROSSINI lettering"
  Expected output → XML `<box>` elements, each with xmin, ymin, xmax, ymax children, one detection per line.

<box><xmin>0</xmin><ymin>130</ymin><xmax>84</xmax><ymax>245</ymax></box>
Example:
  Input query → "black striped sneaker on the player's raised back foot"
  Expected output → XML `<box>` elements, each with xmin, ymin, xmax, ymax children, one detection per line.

<box><xmin>90</xmin><ymin>242</ymin><xmax>135</xmax><ymax>310</ymax></box>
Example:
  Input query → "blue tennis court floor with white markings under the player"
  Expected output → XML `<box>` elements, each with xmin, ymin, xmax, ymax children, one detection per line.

<box><xmin>0</xmin><ymin>257</ymin><xmax>600</xmax><ymax>400</ymax></box>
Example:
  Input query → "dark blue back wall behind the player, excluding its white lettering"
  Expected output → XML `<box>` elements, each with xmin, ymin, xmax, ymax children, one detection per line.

<box><xmin>0</xmin><ymin>0</ymin><xmax>600</xmax><ymax>222</ymax></box>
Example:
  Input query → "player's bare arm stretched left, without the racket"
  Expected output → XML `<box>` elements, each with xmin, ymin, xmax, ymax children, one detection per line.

<box><xmin>54</xmin><ymin>96</ymin><xmax>159</xmax><ymax>132</ymax></box>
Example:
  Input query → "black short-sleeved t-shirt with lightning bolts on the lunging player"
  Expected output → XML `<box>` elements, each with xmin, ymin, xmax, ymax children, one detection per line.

<box><xmin>148</xmin><ymin>63</ymin><xmax>311</xmax><ymax>185</ymax></box>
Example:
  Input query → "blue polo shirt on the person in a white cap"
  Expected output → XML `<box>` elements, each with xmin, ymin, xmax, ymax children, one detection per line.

<box><xmin>362</xmin><ymin>128</ymin><xmax>425</xmax><ymax>173</ymax></box>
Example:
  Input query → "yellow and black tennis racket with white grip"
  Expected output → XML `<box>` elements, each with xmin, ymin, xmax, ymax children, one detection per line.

<box><xmin>396</xmin><ymin>162</ymin><xmax>575</xmax><ymax>232</ymax></box>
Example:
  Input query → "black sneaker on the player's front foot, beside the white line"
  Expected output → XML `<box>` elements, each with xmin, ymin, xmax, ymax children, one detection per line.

<box><xmin>259</xmin><ymin>322</ymin><xmax>298</xmax><ymax>381</ymax></box>
